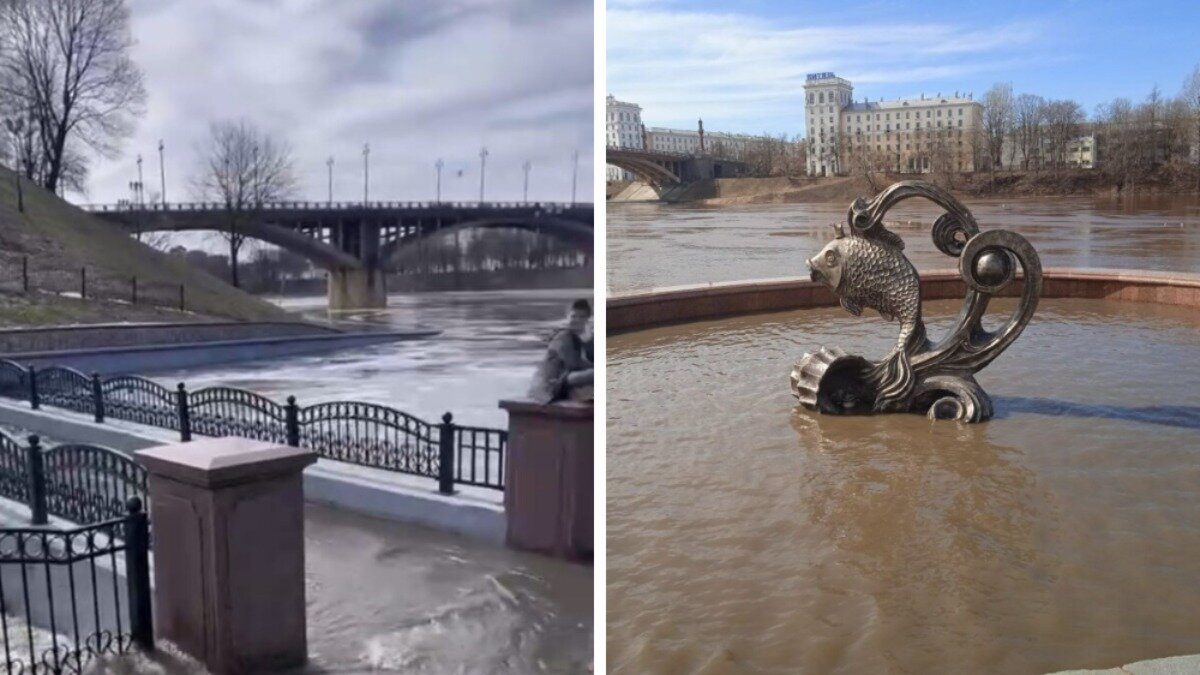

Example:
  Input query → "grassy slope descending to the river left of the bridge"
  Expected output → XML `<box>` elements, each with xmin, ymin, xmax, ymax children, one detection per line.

<box><xmin>0</xmin><ymin>167</ymin><xmax>290</xmax><ymax>325</ymax></box>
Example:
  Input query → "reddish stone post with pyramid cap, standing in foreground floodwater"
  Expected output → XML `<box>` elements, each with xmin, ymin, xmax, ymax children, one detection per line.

<box><xmin>134</xmin><ymin>438</ymin><xmax>317</xmax><ymax>674</ymax></box>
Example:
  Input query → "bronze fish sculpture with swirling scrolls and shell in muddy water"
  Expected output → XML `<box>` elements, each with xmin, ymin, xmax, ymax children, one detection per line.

<box><xmin>791</xmin><ymin>180</ymin><xmax>1042</xmax><ymax>422</ymax></box>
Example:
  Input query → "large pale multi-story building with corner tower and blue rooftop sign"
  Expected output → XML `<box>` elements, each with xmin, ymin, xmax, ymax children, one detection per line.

<box><xmin>804</xmin><ymin>72</ymin><xmax>983</xmax><ymax>175</ymax></box>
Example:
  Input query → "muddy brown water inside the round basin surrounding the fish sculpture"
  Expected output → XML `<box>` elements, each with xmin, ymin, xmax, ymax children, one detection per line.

<box><xmin>606</xmin><ymin>296</ymin><xmax>1200</xmax><ymax>674</ymax></box>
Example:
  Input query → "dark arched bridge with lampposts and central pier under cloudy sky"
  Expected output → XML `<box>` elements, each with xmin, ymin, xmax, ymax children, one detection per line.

<box><xmin>82</xmin><ymin>196</ymin><xmax>594</xmax><ymax>309</ymax></box>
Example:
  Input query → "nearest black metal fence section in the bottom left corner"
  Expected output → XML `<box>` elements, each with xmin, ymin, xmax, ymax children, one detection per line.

<box><xmin>0</xmin><ymin>497</ymin><xmax>154</xmax><ymax>674</ymax></box>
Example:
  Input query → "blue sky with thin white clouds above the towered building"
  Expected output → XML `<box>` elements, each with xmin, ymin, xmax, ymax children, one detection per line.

<box><xmin>607</xmin><ymin>0</ymin><xmax>1200</xmax><ymax>135</ymax></box>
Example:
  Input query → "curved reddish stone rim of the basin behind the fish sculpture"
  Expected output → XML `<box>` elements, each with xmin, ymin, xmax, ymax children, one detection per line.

<box><xmin>606</xmin><ymin>268</ymin><xmax>1200</xmax><ymax>334</ymax></box>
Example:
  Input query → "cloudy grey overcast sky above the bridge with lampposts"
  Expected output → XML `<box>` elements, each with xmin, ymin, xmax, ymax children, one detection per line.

<box><xmin>70</xmin><ymin>0</ymin><xmax>593</xmax><ymax>202</ymax></box>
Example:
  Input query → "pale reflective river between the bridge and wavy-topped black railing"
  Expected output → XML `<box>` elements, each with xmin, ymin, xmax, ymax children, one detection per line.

<box><xmin>154</xmin><ymin>288</ymin><xmax>592</xmax><ymax>426</ymax></box>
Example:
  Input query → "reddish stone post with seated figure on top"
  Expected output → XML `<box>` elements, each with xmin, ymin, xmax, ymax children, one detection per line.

<box><xmin>500</xmin><ymin>400</ymin><xmax>594</xmax><ymax>560</ymax></box>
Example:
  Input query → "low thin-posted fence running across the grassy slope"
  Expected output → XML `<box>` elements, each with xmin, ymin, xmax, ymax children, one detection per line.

<box><xmin>0</xmin><ymin>253</ymin><xmax>187</xmax><ymax>311</ymax></box>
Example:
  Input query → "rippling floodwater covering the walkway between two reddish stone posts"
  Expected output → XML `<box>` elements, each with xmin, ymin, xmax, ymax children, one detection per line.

<box><xmin>305</xmin><ymin>504</ymin><xmax>593</xmax><ymax>674</ymax></box>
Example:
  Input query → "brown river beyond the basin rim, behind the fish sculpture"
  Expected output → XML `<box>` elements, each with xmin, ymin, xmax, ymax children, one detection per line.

<box><xmin>606</xmin><ymin>197</ymin><xmax>1200</xmax><ymax>291</ymax></box>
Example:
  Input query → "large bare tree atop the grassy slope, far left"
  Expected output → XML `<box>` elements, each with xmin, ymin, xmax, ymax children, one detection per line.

<box><xmin>0</xmin><ymin>0</ymin><xmax>145</xmax><ymax>191</ymax></box>
